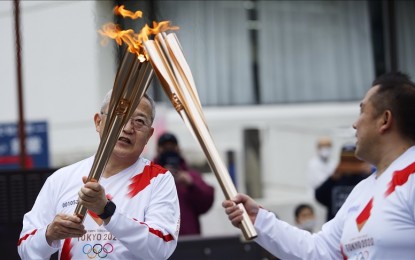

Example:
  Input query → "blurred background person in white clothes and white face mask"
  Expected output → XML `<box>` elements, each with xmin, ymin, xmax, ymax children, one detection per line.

<box><xmin>306</xmin><ymin>136</ymin><xmax>336</xmax><ymax>197</ymax></box>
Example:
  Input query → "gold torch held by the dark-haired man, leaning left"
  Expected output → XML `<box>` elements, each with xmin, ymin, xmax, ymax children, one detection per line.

<box><xmin>144</xmin><ymin>32</ymin><xmax>257</xmax><ymax>240</ymax></box>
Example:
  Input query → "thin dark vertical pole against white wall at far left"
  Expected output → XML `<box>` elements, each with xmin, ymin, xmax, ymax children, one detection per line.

<box><xmin>14</xmin><ymin>0</ymin><xmax>26</xmax><ymax>169</ymax></box>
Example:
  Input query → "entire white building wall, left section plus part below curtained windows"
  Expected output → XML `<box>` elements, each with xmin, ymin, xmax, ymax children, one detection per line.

<box><xmin>0</xmin><ymin>1</ymin><xmax>358</xmax><ymax>238</ymax></box>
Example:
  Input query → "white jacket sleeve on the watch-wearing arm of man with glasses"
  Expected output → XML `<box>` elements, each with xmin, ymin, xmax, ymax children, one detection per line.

<box><xmin>105</xmin><ymin>173</ymin><xmax>180</xmax><ymax>259</ymax></box>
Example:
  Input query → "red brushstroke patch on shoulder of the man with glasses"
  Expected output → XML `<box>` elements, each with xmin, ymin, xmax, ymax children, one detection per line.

<box><xmin>128</xmin><ymin>162</ymin><xmax>167</xmax><ymax>198</ymax></box>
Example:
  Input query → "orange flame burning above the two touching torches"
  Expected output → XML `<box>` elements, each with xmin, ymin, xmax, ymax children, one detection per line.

<box><xmin>98</xmin><ymin>5</ymin><xmax>179</xmax><ymax>62</ymax></box>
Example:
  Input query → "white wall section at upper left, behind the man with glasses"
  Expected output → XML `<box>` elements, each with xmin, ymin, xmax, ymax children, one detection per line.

<box><xmin>0</xmin><ymin>1</ymin><xmax>116</xmax><ymax>166</ymax></box>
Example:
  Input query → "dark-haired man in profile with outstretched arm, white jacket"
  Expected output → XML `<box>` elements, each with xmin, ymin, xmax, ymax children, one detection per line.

<box><xmin>222</xmin><ymin>72</ymin><xmax>415</xmax><ymax>259</ymax></box>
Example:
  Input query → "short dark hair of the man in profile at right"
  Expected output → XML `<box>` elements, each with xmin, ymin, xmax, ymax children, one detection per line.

<box><xmin>371</xmin><ymin>72</ymin><xmax>415</xmax><ymax>141</ymax></box>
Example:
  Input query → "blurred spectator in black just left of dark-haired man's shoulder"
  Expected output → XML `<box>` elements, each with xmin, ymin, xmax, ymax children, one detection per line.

<box><xmin>315</xmin><ymin>144</ymin><xmax>371</xmax><ymax>221</ymax></box>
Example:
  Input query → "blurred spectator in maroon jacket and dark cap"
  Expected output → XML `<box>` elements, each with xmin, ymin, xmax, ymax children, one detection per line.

<box><xmin>154</xmin><ymin>133</ymin><xmax>214</xmax><ymax>235</ymax></box>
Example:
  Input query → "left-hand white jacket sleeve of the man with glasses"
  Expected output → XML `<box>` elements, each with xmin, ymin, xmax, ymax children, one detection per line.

<box><xmin>17</xmin><ymin>177</ymin><xmax>60</xmax><ymax>259</ymax></box>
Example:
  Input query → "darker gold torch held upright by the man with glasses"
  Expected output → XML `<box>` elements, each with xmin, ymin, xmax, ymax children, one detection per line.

<box><xmin>75</xmin><ymin>50</ymin><xmax>154</xmax><ymax>221</ymax></box>
